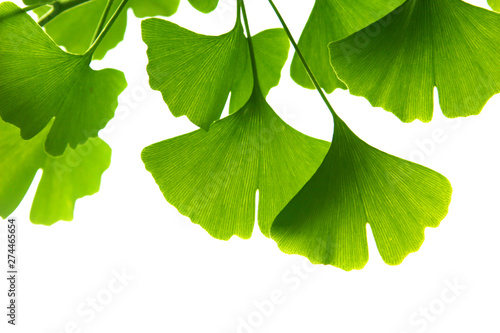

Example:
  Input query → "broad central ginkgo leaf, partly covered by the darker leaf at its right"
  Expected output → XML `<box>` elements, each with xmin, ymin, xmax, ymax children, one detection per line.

<box><xmin>142</xmin><ymin>90</ymin><xmax>329</xmax><ymax>240</ymax></box>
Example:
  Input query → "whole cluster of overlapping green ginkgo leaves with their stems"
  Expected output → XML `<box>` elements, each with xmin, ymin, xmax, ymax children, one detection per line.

<box><xmin>0</xmin><ymin>0</ymin><xmax>500</xmax><ymax>270</ymax></box>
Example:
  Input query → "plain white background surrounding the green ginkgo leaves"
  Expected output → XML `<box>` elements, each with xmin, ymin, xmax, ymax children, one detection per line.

<box><xmin>0</xmin><ymin>0</ymin><xmax>500</xmax><ymax>333</ymax></box>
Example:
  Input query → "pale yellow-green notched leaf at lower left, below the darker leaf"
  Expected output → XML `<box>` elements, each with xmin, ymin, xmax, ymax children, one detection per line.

<box><xmin>0</xmin><ymin>121</ymin><xmax>111</xmax><ymax>225</ymax></box>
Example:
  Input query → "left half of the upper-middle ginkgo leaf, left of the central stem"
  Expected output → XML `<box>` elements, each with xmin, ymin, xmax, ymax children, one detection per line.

<box><xmin>142</xmin><ymin>19</ymin><xmax>246</xmax><ymax>130</ymax></box>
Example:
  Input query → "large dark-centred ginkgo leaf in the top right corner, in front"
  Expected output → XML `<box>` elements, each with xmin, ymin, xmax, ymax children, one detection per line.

<box><xmin>330</xmin><ymin>0</ymin><xmax>500</xmax><ymax>122</ymax></box>
